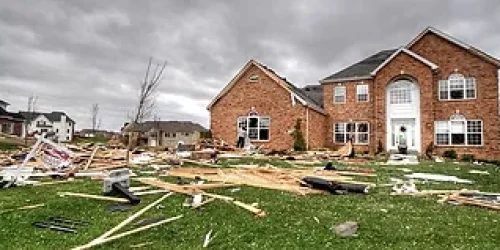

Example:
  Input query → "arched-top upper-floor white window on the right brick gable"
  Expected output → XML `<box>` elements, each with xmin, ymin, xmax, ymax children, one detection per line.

<box><xmin>439</xmin><ymin>73</ymin><xmax>476</xmax><ymax>100</ymax></box>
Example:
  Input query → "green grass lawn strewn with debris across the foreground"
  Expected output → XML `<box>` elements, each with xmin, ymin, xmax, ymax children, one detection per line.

<box><xmin>0</xmin><ymin>161</ymin><xmax>500</xmax><ymax>249</ymax></box>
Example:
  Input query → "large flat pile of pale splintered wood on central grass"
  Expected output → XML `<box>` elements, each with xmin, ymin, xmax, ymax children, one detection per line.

<box><xmin>157</xmin><ymin>167</ymin><xmax>374</xmax><ymax>195</ymax></box>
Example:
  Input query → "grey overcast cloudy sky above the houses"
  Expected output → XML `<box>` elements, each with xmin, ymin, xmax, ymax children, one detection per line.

<box><xmin>0</xmin><ymin>0</ymin><xmax>500</xmax><ymax>130</ymax></box>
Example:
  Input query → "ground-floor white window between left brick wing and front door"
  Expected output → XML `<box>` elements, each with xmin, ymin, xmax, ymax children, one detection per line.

<box><xmin>334</xmin><ymin>122</ymin><xmax>369</xmax><ymax>144</ymax></box>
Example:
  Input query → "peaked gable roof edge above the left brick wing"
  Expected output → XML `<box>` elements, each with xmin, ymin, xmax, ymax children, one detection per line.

<box><xmin>207</xmin><ymin>59</ymin><xmax>325</xmax><ymax>114</ymax></box>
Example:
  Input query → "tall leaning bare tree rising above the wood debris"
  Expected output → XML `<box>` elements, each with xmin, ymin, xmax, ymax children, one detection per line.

<box><xmin>126</xmin><ymin>57</ymin><xmax>167</xmax><ymax>164</ymax></box>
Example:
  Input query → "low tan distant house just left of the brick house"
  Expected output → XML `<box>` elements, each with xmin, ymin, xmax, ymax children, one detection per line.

<box><xmin>125</xmin><ymin>121</ymin><xmax>207</xmax><ymax>148</ymax></box>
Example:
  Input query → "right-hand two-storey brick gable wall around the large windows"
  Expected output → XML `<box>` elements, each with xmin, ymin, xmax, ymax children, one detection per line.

<box><xmin>410</xmin><ymin>33</ymin><xmax>500</xmax><ymax>158</ymax></box>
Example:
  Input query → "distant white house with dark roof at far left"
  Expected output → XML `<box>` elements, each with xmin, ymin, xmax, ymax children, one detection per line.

<box><xmin>19</xmin><ymin>111</ymin><xmax>75</xmax><ymax>142</ymax></box>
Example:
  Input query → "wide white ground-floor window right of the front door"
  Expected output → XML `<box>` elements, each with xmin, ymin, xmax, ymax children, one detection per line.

<box><xmin>434</xmin><ymin>119</ymin><xmax>484</xmax><ymax>147</ymax></box>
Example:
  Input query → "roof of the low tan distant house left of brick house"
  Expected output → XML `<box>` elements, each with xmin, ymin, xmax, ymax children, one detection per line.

<box><xmin>124</xmin><ymin>121</ymin><xmax>207</xmax><ymax>133</ymax></box>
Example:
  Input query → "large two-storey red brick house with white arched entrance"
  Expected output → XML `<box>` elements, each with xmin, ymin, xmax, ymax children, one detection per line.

<box><xmin>208</xmin><ymin>27</ymin><xmax>500</xmax><ymax>159</ymax></box>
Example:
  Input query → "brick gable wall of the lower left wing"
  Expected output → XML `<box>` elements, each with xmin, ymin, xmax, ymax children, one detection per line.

<box><xmin>210</xmin><ymin>65</ymin><xmax>324</xmax><ymax>150</ymax></box>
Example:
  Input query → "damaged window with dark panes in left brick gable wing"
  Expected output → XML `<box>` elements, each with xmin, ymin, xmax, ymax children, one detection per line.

<box><xmin>238</xmin><ymin>114</ymin><xmax>271</xmax><ymax>141</ymax></box>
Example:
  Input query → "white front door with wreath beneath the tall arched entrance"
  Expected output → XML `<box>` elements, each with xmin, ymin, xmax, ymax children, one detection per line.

<box><xmin>390</xmin><ymin>119</ymin><xmax>418</xmax><ymax>150</ymax></box>
